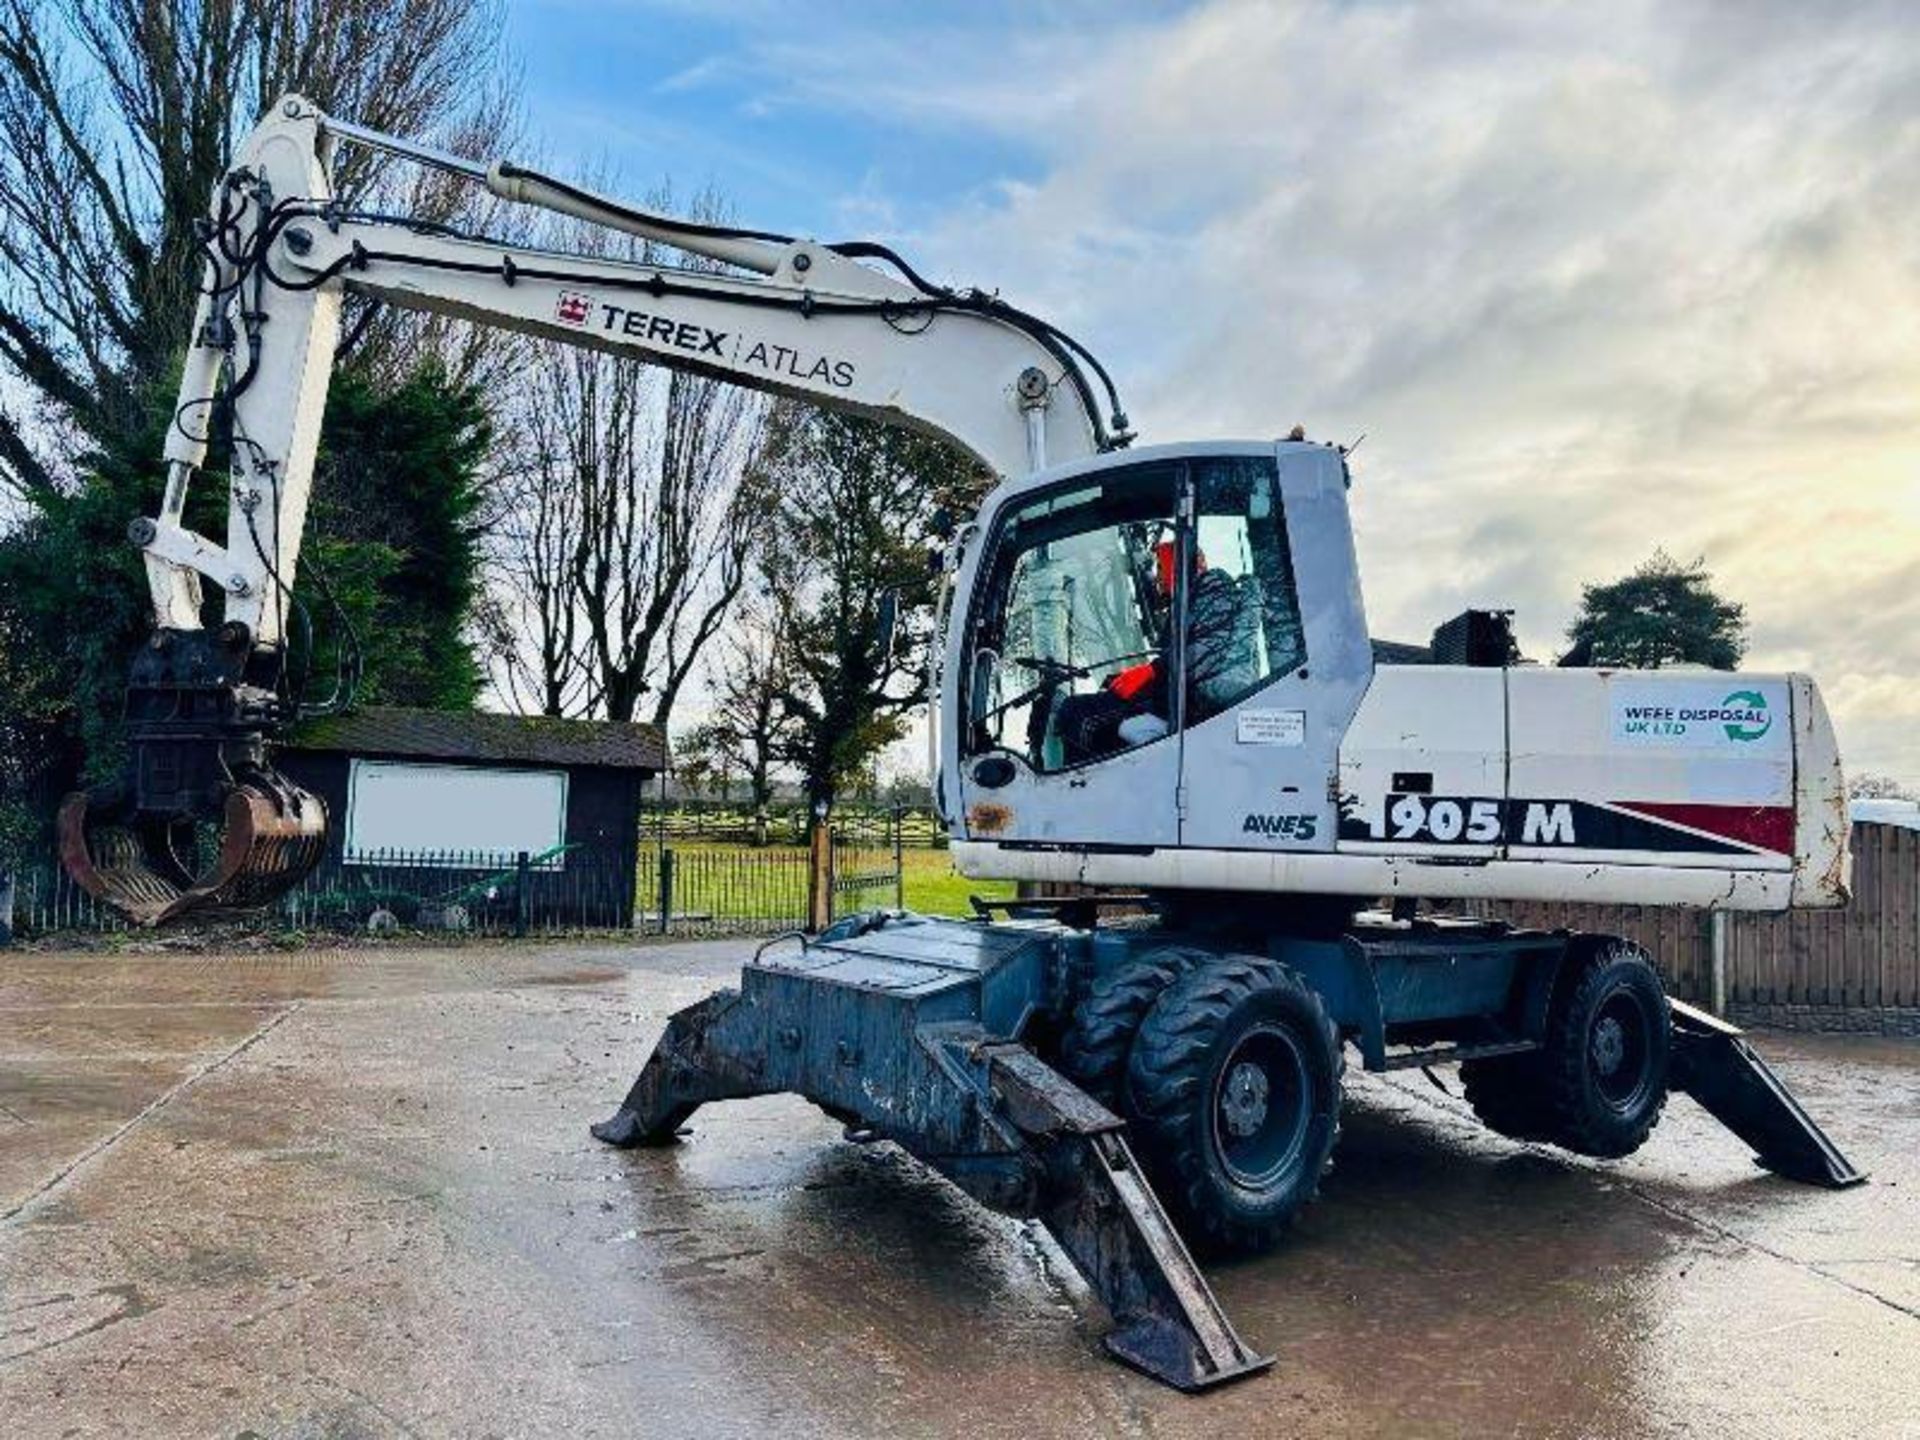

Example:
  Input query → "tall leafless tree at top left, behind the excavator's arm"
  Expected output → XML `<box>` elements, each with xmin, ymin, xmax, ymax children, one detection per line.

<box><xmin>0</xmin><ymin>0</ymin><xmax>513</xmax><ymax>503</ymax></box>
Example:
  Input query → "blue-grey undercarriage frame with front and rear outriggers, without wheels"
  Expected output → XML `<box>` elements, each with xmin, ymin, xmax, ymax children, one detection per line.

<box><xmin>593</xmin><ymin>906</ymin><xmax>1864</xmax><ymax>1390</ymax></box>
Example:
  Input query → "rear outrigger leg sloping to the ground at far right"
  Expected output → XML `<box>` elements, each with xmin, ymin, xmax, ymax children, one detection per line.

<box><xmin>1668</xmin><ymin>998</ymin><xmax>1866</xmax><ymax>1190</ymax></box>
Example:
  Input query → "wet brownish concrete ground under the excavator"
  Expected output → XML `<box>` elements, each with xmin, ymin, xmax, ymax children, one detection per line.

<box><xmin>0</xmin><ymin>945</ymin><xmax>1920</xmax><ymax>1440</ymax></box>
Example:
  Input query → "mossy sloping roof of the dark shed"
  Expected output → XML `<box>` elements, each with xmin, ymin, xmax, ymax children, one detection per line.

<box><xmin>286</xmin><ymin>705</ymin><xmax>666</xmax><ymax>772</ymax></box>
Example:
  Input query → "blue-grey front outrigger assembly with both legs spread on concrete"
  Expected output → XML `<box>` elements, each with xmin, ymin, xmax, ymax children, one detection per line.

<box><xmin>593</xmin><ymin>925</ymin><xmax>1273</xmax><ymax>1390</ymax></box>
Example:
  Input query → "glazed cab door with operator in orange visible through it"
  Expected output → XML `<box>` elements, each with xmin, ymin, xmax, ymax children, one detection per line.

<box><xmin>958</xmin><ymin>463</ymin><xmax>1183</xmax><ymax>851</ymax></box>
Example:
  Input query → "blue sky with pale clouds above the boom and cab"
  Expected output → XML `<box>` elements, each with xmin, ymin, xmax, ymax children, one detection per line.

<box><xmin>509</xmin><ymin>0</ymin><xmax>1920</xmax><ymax>783</ymax></box>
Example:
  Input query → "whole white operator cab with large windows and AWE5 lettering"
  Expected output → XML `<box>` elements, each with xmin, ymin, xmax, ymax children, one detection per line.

<box><xmin>945</xmin><ymin>442</ymin><xmax>1371</xmax><ymax>864</ymax></box>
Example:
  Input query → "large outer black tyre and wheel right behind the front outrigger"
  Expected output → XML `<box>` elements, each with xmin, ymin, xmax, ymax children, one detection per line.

<box><xmin>1127</xmin><ymin>956</ymin><xmax>1342</xmax><ymax>1252</ymax></box>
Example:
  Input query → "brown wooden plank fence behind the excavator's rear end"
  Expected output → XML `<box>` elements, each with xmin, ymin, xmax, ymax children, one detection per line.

<box><xmin>1494</xmin><ymin>824</ymin><xmax>1920</xmax><ymax>1029</ymax></box>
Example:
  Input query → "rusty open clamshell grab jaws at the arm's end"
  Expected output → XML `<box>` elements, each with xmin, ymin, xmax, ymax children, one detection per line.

<box><xmin>60</xmin><ymin>778</ymin><xmax>326</xmax><ymax>925</ymax></box>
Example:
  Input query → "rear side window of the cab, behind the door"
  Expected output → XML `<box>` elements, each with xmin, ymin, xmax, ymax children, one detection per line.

<box><xmin>1185</xmin><ymin>455</ymin><xmax>1308</xmax><ymax>724</ymax></box>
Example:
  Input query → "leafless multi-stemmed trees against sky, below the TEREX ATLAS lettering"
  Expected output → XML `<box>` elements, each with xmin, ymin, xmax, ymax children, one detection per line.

<box><xmin>483</xmin><ymin>194</ymin><xmax>768</xmax><ymax>724</ymax></box>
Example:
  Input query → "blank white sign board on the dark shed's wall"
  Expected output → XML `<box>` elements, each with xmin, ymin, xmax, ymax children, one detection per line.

<box><xmin>346</xmin><ymin>760</ymin><xmax>566</xmax><ymax>866</ymax></box>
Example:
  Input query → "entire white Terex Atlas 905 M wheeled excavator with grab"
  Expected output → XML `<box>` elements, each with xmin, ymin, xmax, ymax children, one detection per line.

<box><xmin>60</xmin><ymin>96</ymin><xmax>1860</xmax><ymax>1388</ymax></box>
